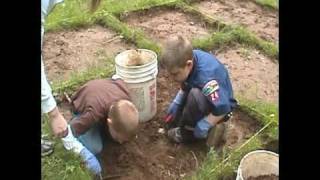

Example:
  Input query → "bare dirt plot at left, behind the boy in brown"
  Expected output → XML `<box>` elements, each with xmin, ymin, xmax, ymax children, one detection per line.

<box><xmin>43</xmin><ymin>26</ymin><xmax>134</xmax><ymax>81</ymax></box>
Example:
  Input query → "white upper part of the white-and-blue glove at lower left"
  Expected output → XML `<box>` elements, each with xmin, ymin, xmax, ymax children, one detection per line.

<box><xmin>61</xmin><ymin>125</ymin><xmax>85</xmax><ymax>154</ymax></box>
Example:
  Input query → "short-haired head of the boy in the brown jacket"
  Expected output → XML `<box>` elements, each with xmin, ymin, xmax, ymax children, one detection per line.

<box><xmin>109</xmin><ymin>100</ymin><xmax>139</xmax><ymax>138</ymax></box>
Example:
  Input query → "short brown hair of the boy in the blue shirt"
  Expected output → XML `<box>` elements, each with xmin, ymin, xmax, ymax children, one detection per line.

<box><xmin>161</xmin><ymin>35</ymin><xmax>193</xmax><ymax>70</ymax></box>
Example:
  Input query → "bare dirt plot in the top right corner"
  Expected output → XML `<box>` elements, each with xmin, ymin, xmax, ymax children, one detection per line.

<box><xmin>195</xmin><ymin>0</ymin><xmax>279</xmax><ymax>43</ymax></box>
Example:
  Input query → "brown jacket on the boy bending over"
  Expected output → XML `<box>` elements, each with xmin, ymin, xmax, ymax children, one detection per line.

<box><xmin>70</xmin><ymin>79</ymin><xmax>130</xmax><ymax>136</ymax></box>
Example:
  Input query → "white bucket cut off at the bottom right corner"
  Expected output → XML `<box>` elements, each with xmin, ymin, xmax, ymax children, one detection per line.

<box><xmin>236</xmin><ymin>150</ymin><xmax>279</xmax><ymax>180</ymax></box>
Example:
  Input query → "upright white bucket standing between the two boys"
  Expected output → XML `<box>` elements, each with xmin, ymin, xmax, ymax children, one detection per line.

<box><xmin>115</xmin><ymin>49</ymin><xmax>158</xmax><ymax>122</ymax></box>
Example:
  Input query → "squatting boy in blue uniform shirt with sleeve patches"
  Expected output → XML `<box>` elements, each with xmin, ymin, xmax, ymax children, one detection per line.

<box><xmin>162</xmin><ymin>36</ymin><xmax>237</xmax><ymax>144</ymax></box>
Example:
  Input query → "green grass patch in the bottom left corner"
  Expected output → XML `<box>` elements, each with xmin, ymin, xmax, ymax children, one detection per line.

<box><xmin>41</xmin><ymin>116</ymin><xmax>93</xmax><ymax>180</ymax></box>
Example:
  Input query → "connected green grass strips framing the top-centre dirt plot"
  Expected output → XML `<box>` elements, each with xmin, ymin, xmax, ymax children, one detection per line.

<box><xmin>46</xmin><ymin>0</ymin><xmax>278</xmax><ymax>59</ymax></box>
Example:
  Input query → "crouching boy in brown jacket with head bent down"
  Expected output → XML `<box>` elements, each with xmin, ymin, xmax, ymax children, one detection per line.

<box><xmin>62</xmin><ymin>79</ymin><xmax>139</xmax><ymax>175</ymax></box>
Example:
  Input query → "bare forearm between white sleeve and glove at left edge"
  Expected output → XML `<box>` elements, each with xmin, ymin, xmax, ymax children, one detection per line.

<box><xmin>49</xmin><ymin>107</ymin><xmax>68</xmax><ymax>138</ymax></box>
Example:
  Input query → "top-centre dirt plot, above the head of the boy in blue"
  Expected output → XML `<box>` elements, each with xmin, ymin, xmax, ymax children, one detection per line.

<box><xmin>124</xmin><ymin>9</ymin><xmax>210</xmax><ymax>43</ymax></box>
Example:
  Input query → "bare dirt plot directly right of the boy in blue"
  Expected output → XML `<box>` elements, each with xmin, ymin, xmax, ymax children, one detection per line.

<box><xmin>215</xmin><ymin>47</ymin><xmax>279</xmax><ymax>103</ymax></box>
